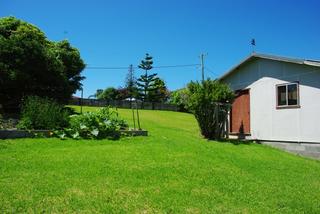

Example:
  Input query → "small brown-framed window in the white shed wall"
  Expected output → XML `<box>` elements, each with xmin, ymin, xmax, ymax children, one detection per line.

<box><xmin>277</xmin><ymin>83</ymin><xmax>299</xmax><ymax>108</ymax></box>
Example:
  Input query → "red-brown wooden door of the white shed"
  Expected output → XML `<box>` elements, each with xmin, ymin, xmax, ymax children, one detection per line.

<box><xmin>230</xmin><ymin>90</ymin><xmax>250</xmax><ymax>134</ymax></box>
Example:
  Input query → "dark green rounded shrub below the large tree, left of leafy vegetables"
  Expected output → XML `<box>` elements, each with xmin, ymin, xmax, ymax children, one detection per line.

<box><xmin>18</xmin><ymin>96</ymin><xmax>69</xmax><ymax>130</ymax></box>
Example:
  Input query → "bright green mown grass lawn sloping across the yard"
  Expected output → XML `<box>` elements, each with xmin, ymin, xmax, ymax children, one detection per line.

<box><xmin>0</xmin><ymin>107</ymin><xmax>320</xmax><ymax>213</ymax></box>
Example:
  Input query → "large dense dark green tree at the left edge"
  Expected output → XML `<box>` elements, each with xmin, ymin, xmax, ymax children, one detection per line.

<box><xmin>0</xmin><ymin>17</ymin><xmax>85</xmax><ymax>112</ymax></box>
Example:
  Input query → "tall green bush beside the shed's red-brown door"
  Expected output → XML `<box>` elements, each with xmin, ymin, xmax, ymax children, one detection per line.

<box><xmin>187</xmin><ymin>79</ymin><xmax>234</xmax><ymax>139</ymax></box>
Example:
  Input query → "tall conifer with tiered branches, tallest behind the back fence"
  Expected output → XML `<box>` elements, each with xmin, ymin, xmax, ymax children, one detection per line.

<box><xmin>137</xmin><ymin>53</ymin><xmax>158</xmax><ymax>102</ymax></box>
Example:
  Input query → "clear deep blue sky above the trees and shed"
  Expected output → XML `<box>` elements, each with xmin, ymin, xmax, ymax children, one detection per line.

<box><xmin>0</xmin><ymin>0</ymin><xmax>320</xmax><ymax>97</ymax></box>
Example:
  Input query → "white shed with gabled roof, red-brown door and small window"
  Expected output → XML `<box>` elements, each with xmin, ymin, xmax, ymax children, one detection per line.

<box><xmin>220</xmin><ymin>53</ymin><xmax>320</xmax><ymax>143</ymax></box>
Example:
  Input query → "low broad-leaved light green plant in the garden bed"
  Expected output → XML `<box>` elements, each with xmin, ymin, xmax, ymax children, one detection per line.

<box><xmin>56</xmin><ymin>107</ymin><xmax>128</xmax><ymax>139</ymax></box>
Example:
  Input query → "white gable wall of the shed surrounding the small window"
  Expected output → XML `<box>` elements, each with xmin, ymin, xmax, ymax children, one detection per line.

<box><xmin>223</xmin><ymin>59</ymin><xmax>320</xmax><ymax>143</ymax></box>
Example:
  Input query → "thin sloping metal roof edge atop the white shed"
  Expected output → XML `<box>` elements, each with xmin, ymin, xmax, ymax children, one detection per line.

<box><xmin>219</xmin><ymin>53</ymin><xmax>320</xmax><ymax>79</ymax></box>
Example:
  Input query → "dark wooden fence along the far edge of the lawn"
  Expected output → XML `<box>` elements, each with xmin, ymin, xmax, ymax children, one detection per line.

<box><xmin>69</xmin><ymin>98</ymin><xmax>179</xmax><ymax>111</ymax></box>
